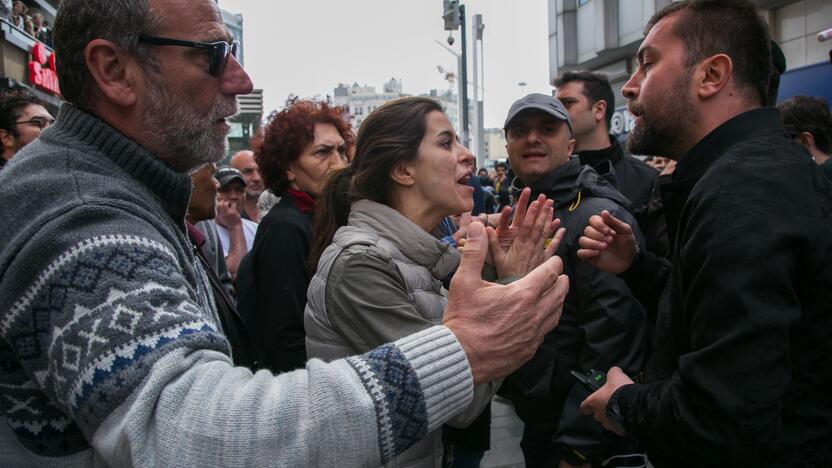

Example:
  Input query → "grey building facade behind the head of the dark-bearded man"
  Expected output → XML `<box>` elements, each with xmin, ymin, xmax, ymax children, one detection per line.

<box><xmin>548</xmin><ymin>0</ymin><xmax>832</xmax><ymax>139</ymax></box>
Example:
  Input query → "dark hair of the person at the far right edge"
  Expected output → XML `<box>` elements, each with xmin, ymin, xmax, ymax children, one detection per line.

<box><xmin>777</xmin><ymin>96</ymin><xmax>832</xmax><ymax>154</ymax></box>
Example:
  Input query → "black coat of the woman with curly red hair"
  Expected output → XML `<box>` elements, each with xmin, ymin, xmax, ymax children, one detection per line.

<box><xmin>237</xmin><ymin>194</ymin><xmax>312</xmax><ymax>373</ymax></box>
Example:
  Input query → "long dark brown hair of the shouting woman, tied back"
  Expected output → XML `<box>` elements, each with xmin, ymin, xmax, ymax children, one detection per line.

<box><xmin>309</xmin><ymin>97</ymin><xmax>443</xmax><ymax>272</ymax></box>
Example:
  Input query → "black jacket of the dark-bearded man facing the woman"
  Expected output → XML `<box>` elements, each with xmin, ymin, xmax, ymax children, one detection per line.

<box><xmin>617</xmin><ymin>108</ymin><xmax>832</xmax><ymax>467</ymax></box>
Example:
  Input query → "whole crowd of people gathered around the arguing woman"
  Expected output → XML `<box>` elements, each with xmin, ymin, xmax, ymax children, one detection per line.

<box><xmin>0</xmin><ymin>0</ymin><xmax>832</xmax><ymax>468</ymax></box>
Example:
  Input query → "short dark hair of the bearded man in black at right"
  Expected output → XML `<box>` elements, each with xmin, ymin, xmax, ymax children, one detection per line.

<box><xmin>644</xmin><ymin>0</ymin><xmax>772</xmax><ymax>105</ymax></box>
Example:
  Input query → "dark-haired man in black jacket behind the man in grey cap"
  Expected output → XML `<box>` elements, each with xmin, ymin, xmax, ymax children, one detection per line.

<box><xmin>555</xmin><ymin>71</ymin><xmax>659</xmax><ymax>215</ymax></box>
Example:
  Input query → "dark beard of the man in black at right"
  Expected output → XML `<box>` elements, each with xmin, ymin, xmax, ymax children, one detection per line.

<box><xmin>627</xmin><ymin>75</ymin><xmax>700</xmax><ymax>160</ymax></box>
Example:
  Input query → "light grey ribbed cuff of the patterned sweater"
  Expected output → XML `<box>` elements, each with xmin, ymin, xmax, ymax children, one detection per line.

<box><xmin>395</xmin><ymin>326</ymin><xmax>474</xmax><ymax>431</ymax></box>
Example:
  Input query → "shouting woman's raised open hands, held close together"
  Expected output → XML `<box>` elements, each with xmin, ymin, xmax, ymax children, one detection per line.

<box><xmin>488</xmin><ymin>188</ymin><xmax>566</xmax><ymax>278</ymax></box>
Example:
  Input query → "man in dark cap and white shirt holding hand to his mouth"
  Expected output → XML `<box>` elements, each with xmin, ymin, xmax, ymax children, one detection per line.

<box><xmin>208</xmin><ymin>166</ymin><xmax>257</xmax><ymax>278</ymax></box>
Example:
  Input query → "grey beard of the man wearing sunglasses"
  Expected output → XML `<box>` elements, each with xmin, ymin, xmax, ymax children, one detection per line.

<box><xmin>143</xmin><ymin>79</ymin><xmax>237</xmax><ymax>173</ymax></box>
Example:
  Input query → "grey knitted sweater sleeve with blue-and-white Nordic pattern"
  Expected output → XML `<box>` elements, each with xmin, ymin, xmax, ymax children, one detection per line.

<box><xmin>0</xmin><ymin>207</ymin><xmax>471</xmax><ymax>467</ymax></box>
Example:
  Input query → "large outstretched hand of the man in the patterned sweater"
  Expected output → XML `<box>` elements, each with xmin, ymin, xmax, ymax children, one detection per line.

<box><xmin>444</xmin><ymin>222</ymin><xmax>569</xmax><ymax>384</ymax></box>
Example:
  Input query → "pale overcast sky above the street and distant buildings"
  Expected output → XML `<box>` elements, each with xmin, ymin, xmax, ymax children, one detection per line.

<box><xmin>219</xmin><ymin>0</ymin><xmax>552</xmax><ymax>128</ymax></box>
